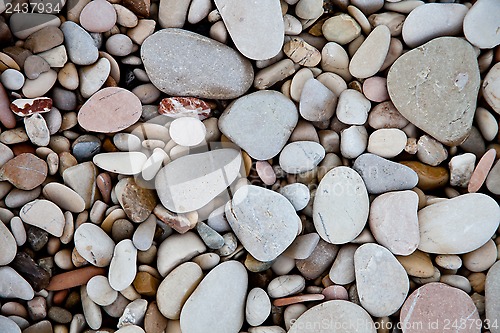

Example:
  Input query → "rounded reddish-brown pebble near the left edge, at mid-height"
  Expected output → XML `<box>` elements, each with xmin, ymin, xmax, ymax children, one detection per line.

<box><xmin>0</xmin><ymin>154</ymin><xmax>48</xmax><ymax>191</ymax></box>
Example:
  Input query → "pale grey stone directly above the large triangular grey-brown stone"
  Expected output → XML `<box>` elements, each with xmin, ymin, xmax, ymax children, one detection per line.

<box><xmin>402</xmin><ymin>3</ymin><xmax>468</xmax><ymax>48</ymax></box>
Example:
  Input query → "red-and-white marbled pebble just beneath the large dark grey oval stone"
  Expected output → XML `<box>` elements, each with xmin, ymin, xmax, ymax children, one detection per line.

<box><xmin>158</xmin><ymin>97</ymin><xmax>210</xmax><ymax>120</ymax></box>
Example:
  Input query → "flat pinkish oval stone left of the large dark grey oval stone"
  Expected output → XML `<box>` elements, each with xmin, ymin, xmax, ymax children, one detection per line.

<box><xmin>78</xmin><ymin>87</ymin><xmax>142</xmax><ymax>133</ymax></box>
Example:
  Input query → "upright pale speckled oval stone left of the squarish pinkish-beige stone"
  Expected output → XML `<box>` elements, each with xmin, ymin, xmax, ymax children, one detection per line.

<box><xmin>313</xmin><ymin>166</ymin><xmax>369</xmax><ymax>244</ymax></box>
